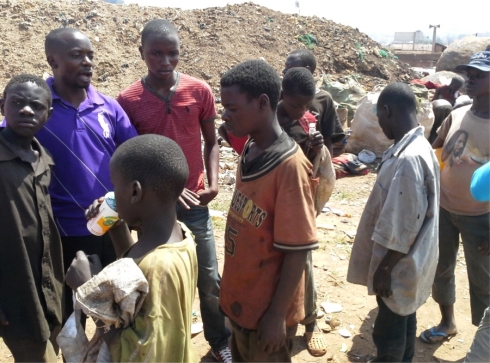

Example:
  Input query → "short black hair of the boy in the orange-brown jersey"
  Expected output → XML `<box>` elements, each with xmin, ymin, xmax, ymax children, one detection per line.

<box><xmin>220</xmin><ymin>59</ymin><xmax>281</xmax><ymax>111</ymax></box>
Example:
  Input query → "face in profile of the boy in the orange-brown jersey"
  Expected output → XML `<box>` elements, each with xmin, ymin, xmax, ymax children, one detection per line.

<box><xmin>221</xmin><ymin>86</ymin><xmax>260</xmax><ymax>137</ymax></box>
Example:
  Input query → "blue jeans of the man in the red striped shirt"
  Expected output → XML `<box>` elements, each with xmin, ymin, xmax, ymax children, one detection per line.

<box><xmin>177</xmin><ymin>204</ymin><xmax>231</xmax><ymax>351</ymax></box>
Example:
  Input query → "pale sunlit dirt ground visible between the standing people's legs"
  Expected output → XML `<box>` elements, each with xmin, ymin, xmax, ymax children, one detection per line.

<box><xmin>0</xmin><ymin>173</ymin><xmax>476</xmax><ymax>363</ymax></box>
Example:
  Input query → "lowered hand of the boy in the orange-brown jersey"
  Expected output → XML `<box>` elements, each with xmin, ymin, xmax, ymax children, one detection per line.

<box><xmin>257</xmin><ymin>311</ymin><xmax>286</xmax><ymax>354</ymax></box>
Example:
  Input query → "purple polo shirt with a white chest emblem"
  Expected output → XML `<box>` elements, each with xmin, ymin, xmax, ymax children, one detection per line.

<box><xmin>36</xmin><ymin>77</ymin><xmax>137</xmax><ymax>236</ymax></box>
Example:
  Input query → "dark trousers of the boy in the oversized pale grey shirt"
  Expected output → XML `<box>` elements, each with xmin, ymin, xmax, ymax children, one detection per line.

<box><xmin>372</xmin><ymin>296</ymin><xmax>417</xmax><ymax>362</ymax></box>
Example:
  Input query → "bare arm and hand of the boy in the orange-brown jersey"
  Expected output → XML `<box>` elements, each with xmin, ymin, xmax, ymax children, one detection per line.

<box><xmin>257</xmin><ymin>251</ymin><xmax>308</xmax><ymax>354</ymax></box>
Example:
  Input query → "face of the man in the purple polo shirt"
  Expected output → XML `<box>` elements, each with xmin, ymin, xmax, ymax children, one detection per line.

<box><xmin>48</xmin><ymin>32</ymin><xmax>94</xmax><ymax>88</ymax></box>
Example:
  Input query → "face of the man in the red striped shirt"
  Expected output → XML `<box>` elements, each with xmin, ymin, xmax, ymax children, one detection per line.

<box><xmin>140</xmin><ymin>34</ymin><xmax>180</xmax><ymax>80</ymax></box>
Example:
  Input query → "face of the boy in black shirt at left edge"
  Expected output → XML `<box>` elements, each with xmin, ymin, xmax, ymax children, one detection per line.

<box><xmin>0</xmin><ymin>82</ymin><xmax>53</xmax><ymax>138</ymax></box>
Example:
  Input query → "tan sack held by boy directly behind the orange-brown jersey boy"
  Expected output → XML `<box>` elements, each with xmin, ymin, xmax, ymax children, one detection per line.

<box><xmin>313</xmin><ymin>145</ymin><xmax>336</xmax><ymax>216</ymax></box>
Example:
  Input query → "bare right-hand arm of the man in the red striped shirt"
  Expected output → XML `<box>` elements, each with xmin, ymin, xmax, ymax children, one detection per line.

<box><xmin>199</xmin><ymin>119</ymin><xmax>219</xmax><ymax>205</ymax></box>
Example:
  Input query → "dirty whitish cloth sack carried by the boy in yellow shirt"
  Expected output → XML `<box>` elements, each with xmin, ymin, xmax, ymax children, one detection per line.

<box><xmin>56</xmin><ymin>258</ymin><xmax>148</xmax><ymax>363</ymax></box>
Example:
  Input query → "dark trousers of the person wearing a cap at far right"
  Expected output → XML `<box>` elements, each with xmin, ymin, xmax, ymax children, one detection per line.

<box><xmin>432</xmin><ymin>208</ymin><xmax>490</xmax><ymax>326</ymax></box>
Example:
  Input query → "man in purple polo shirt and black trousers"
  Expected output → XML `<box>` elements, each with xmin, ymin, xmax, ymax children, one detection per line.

<box><xmin>36</xmin><ymin>28</ymin><xmax>137</xmax><ymax>319</ymax></box>
